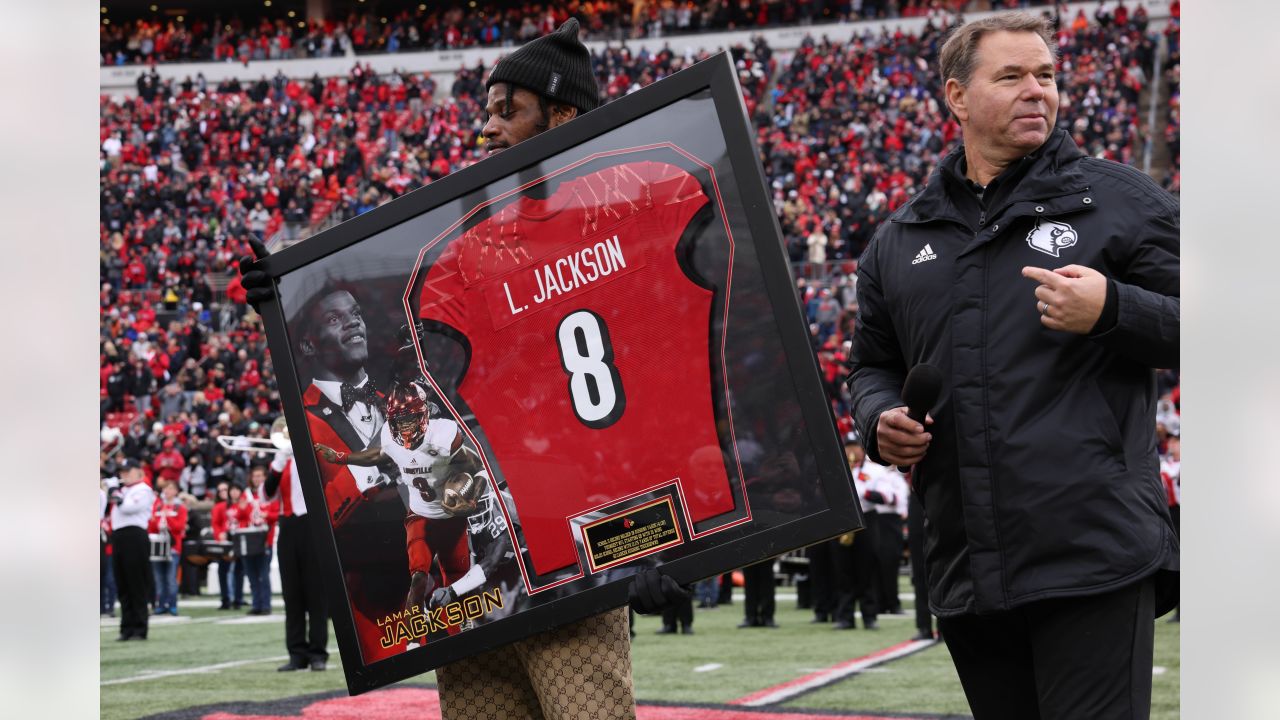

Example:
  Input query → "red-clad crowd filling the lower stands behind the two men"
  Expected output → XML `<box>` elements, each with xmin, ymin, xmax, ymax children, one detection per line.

<box><xmin>100</xmin><ymin>1</ymin><xmax>1178</xmax><ymax>622</ymax></box>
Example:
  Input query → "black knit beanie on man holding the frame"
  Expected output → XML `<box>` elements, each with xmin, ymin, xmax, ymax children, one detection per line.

<box><xmin>484</xmin><ymin>18</ymin><xmax>600</xmax><ymax>113</ymax></box>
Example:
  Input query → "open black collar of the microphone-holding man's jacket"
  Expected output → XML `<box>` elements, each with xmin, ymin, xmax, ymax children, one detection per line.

<box><xmin>893</xmin><ymin>129</ymin><xmax>1088</xmax><ymax>223</ymax></box>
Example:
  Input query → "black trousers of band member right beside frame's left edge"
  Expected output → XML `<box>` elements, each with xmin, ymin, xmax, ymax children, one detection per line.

<box><xmin>276</xmin><ymin>516</ymin><xmax>329</xmax><ymax>665</ymax></box>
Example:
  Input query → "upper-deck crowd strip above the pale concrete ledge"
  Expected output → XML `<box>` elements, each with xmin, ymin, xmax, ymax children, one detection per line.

<box><xmin>99</xmin><ymin>0</ymin><xmax>977</xmax><ymax>65</ymax></box>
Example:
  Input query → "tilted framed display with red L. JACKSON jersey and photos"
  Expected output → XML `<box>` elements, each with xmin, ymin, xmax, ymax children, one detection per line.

<box><xmin>254</xmin><ymin>54</ymin><xmax>861</xmax><ymax>693</ymax></box>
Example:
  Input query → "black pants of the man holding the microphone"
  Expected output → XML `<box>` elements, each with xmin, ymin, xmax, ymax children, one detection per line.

<box><xmin>938</xmin><ymin>579</ymin><xmax>1156</xmax><ymax>720</ymax></box>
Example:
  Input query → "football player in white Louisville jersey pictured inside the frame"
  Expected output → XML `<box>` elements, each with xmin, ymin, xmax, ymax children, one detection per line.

<box><xmin>316</xmin><ymin>382</ymin><xmax>488</xmax><ymax>607</ymax></box>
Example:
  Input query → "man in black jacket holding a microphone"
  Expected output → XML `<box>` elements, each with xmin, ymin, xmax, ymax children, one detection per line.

<box><xmin>850</xmin><ymin>13</ymin><xmax>1180</xmax><ymax>720</ymax></box>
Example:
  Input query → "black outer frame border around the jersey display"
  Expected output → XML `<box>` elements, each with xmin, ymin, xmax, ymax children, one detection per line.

<box><xmin>260</xmin><ymin>53</ymin><xmax>863</xmax><ymax>694</ymax></box>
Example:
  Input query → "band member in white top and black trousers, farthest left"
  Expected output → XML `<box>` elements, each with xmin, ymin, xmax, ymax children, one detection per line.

<box><xmin>110</xmin><ymin>457</ymin><xmax>156</xmax><ymax>641</ymax></box>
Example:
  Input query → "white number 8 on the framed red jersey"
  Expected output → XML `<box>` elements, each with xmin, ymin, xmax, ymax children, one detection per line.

<box><xmin>556</xmin><ymin>310</ymin><xmax>626</xmax><ymax>429</ymax></box>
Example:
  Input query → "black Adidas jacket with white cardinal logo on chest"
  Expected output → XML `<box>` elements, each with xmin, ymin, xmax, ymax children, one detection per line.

<box><xmin>850</xmin><ymin>131</ymin><xmax>1180</xmax><ymax>616</ymax></box>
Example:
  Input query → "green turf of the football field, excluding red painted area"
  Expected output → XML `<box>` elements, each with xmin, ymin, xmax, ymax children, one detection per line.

<box><xmin>101</xmin><ymin>582</ymin><xmax>1179</xmax><ymax>720</ymax></box>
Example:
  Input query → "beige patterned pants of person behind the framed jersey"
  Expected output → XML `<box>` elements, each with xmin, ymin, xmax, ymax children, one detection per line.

<box><xmin>435</xmin><ymin>607</ymin><xmax>636</xmax><ymax>720</ymax></box>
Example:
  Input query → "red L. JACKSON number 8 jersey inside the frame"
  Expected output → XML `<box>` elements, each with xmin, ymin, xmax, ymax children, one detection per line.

<box><xmin>419</xmin><ymin>161</ymin><xmax>733</xmax><ymax>574</ymax></box>
